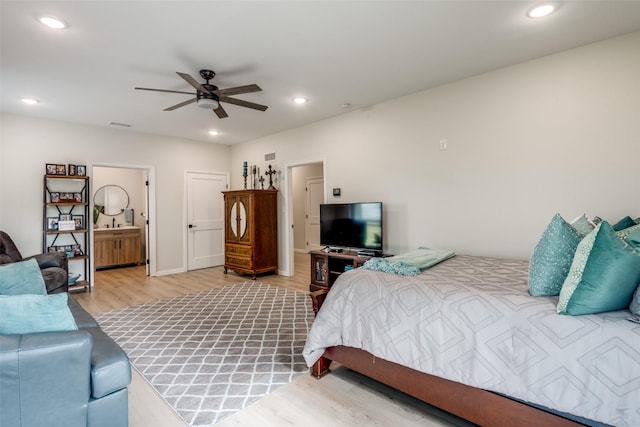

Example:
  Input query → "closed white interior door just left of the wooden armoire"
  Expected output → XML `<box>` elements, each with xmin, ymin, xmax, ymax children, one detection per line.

<box><xmin>187</xmin><ymin>172</ymin><xmax>227</xmax><ymax>270</ymax></box>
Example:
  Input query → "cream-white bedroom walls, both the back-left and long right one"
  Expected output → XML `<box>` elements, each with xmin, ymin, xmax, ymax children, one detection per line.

<box><xmin>0</xmin><ymin>32</ymin><xmax>640</xmax><ymax>271</ymax></box>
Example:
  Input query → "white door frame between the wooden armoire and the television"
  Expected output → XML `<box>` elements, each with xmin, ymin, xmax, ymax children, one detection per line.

<box><xmin>278</xmin><ymin>157</ymin><xmax>327</xmax><ymax>276</ymax></box>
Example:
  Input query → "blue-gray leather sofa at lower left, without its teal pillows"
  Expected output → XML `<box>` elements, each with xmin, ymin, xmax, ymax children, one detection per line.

<box><xmin>0</xmin><ymin>295</ymin><xmax>131</xmax><ymax>427</ymax></box>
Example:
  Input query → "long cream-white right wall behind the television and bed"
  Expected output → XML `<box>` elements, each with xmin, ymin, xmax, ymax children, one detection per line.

<box><xmin>231</xmin><ymin>32</ymin><xmax>640</xmax><ymax>270</ymax></box>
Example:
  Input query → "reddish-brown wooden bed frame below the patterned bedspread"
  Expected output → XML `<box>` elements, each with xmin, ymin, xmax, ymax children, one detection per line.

<box><xmin>310</xmin><ymin>289</ymin><xmax>583</xmax><ymax>427</ymax></box>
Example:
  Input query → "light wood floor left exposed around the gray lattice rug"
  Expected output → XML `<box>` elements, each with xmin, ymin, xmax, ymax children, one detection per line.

<box><xmin>73</xmin><ymin>254</ymin><xmax>470</xmax><ymax>427</ymax></box>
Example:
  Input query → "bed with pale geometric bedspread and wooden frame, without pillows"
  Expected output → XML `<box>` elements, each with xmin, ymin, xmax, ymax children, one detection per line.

<box><xmin>303</xmin><ymin>255</ymin><xmax>640</xmax><ymax>426</ymax></box>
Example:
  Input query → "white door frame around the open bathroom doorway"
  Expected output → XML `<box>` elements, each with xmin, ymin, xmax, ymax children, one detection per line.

<box><xmin>87</xmin><ymin>162</ymin><xmax>158</xmax><ymax>280</ymax></box>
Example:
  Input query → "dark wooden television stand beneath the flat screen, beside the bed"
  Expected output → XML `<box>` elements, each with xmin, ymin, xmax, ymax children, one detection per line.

<box><xmin>309</xmin><ymin>248</ymin><xmax>390</xmax><ymax>292</ymax></box>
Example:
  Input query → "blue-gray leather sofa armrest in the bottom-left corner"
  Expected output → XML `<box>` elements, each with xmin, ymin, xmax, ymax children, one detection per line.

<box><xmin>0</xmin><ymin>331</ymin><xmax>93</xmax><ymax>426</ymax></box>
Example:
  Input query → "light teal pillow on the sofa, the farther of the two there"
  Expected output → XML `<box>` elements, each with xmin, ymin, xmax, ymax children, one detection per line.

<box><xmin>0</xmin><ymin>258</ymin><xmax>47</xmax><ymax>295</ymax></box>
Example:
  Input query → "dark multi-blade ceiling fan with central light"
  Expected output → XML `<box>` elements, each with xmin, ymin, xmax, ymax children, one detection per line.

<box><xmin>135</xmin><ymin>70</ymin><xmax>269</xmax><ymax>119</ymax></box>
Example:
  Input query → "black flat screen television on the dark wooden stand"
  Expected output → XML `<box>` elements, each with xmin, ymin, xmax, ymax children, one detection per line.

<box><xmin>320</xmin><ymin>202</ymin><xmax>382</xmax><ymax>252</ymax></box>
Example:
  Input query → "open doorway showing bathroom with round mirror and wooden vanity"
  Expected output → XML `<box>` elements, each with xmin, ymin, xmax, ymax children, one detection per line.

<box><xmin>91</xmin><ymin>165</ymin><xmax>154</xmax><ymax>286</ymax></box>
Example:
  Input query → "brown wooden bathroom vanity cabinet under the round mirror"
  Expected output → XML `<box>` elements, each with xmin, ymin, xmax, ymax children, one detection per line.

<box><xmin>93</xmin><ymin>227</ymin><xmax>141</xmax><ymax>269</ymax></box>
